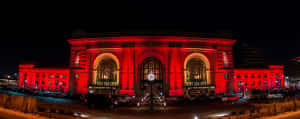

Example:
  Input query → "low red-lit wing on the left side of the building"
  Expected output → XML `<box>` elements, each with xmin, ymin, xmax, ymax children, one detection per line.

<box><xmin>18</xmin><ymin>64</ymin><xmax>70</xmax><ymax>92</ymax></box>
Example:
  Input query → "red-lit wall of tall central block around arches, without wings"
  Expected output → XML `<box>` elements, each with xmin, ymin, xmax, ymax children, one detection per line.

<box><xmin>69</xmin><ymin>36</ymin><xmax>234</xmax><ymax>96</ymax></box>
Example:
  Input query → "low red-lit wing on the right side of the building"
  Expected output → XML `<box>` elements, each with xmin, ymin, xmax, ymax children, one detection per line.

<box><xmin>234</xmin><ymin>65</ymin><xmax>284</xmax><ymax>92</ymax></box>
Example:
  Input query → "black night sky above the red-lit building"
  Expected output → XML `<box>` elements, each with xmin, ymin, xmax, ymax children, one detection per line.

<box><xmin>0</xmin><ymin>1</ymin><xmax>300</xmax><ymax>72</ymax></box>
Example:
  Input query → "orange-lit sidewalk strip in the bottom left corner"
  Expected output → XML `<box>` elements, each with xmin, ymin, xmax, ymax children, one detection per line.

<box><xmin>0</xmin><ymin>107</ymin><xmax>48</xmax><ymax>119</ymax></box>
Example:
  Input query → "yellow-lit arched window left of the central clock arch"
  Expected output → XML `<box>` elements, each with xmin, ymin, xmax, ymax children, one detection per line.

<box><xmin>96</xmin><ymin>58</ymin><xmax>118</xmax><ymax>86</ymax></box>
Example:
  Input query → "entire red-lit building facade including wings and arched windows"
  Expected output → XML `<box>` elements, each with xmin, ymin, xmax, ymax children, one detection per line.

<box><xmin>19</xmin><ymin>36</ymin><xmax>284</xmax><ymax>96</ymax></box>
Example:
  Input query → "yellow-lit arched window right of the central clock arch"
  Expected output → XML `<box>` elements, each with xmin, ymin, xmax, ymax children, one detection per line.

<box><xmin>186</xmin><ymin>58</ymin><xmax>207</xmax><ymax>86</ymax></box>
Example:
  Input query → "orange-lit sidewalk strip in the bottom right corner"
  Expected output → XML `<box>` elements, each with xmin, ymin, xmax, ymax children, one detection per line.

<box><xmin>261</xmin><ymin>110</ymin><xmax>300</xmax><ymax>119</ymax></box>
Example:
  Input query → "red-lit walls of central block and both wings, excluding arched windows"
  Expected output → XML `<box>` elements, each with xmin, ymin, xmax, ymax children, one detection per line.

<box><xmin>19</xmin><ymin>36</ymin><xmax>284</xmax><ymax>96</ymax></box>
